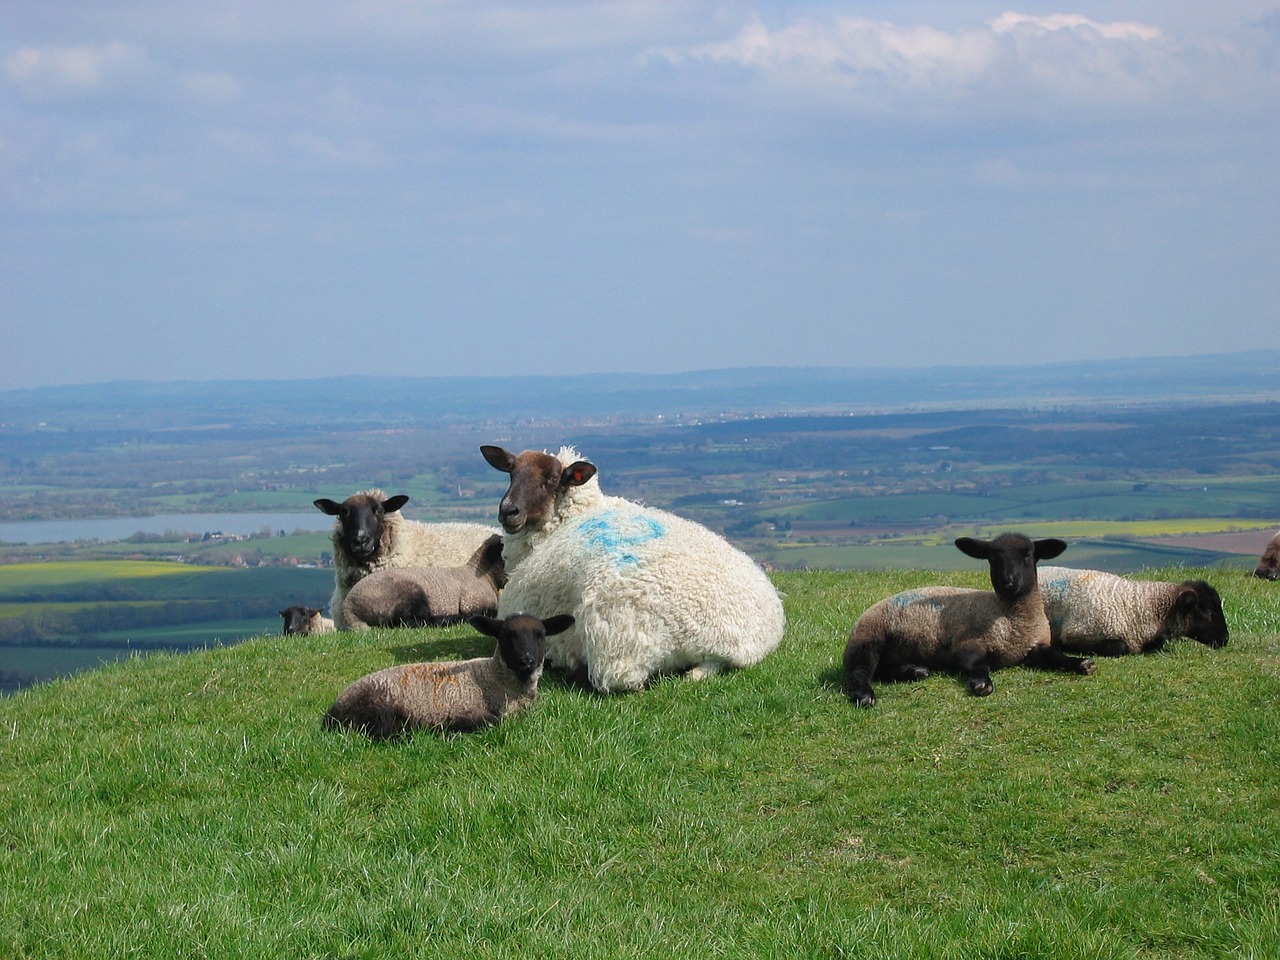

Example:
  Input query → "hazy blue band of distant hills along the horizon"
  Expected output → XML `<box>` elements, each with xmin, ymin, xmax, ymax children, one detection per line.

<box><xmin>0</xmin><ymin>349</ymin><xmax>1280</xmax><ymax>429</ymax></box>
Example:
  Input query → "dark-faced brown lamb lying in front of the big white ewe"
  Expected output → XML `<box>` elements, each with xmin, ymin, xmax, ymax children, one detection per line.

<box><xmin>324</xmin><ymin>613</ymin><xmax>573</xmax><ymax>740</ymax></box>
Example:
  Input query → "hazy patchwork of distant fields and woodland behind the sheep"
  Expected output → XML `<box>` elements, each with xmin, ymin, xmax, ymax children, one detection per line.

<box><xmin>0</xmin><ymin>357</ymin><xmax>1280</xmax><ymax>690</ymax></box>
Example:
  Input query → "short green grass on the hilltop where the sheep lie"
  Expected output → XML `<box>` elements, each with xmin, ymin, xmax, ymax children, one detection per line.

<box><xmin>0</xmin><ymin>570</ymin><xmax>1280</xmax><ymax>960</ymax></box>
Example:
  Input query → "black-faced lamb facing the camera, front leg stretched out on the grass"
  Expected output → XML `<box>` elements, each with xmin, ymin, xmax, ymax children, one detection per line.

<box><xmin>845</xmin><ymin>534</ymin><xmax>1094</xmax><ymax>707</ymax></box>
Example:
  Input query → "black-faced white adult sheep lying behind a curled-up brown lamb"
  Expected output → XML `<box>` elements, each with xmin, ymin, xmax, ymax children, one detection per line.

<box><xmin>314</xmin><ymin>488</ymin><xmax>500</xmax><ymax>630</ymax></box>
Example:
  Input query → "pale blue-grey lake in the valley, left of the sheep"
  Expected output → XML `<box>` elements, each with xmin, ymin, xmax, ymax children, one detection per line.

<box><xmin>0</xmin><ymin>509</ymin><xmax>333</xmax><ymax>544</ymax></box>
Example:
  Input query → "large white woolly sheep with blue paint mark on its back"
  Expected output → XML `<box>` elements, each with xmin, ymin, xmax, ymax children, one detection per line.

<box><xmin>480</xmin><ymin>445</ymin><xmax>786</xmax><ymax>694</ymax></box>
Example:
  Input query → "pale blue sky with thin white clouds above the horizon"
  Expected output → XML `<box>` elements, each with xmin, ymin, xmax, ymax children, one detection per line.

<box><xmin>0</xmin><ymin>0</ymin><xmax>1280</xmax><ymax>389</ymax></box>
